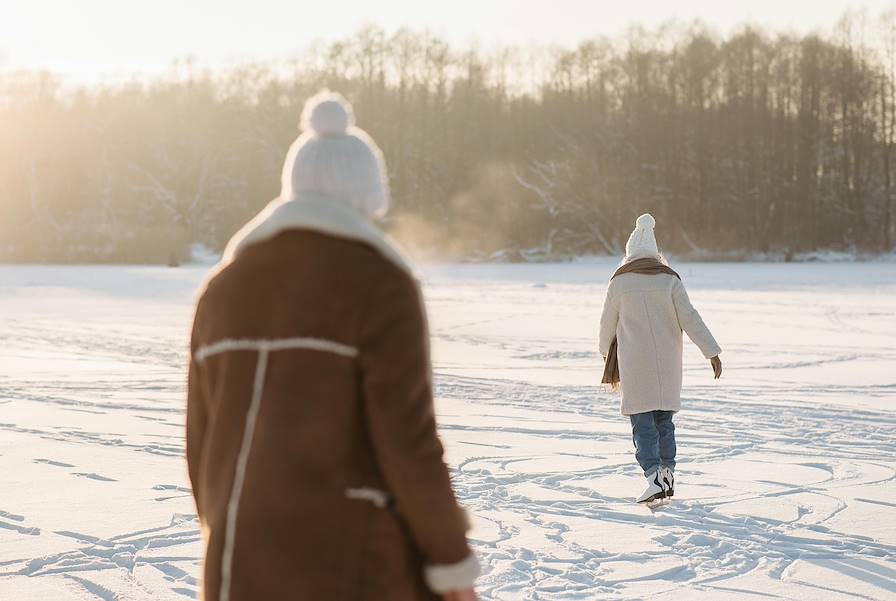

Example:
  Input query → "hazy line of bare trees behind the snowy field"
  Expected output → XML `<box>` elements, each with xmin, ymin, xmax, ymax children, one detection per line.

<box><xmin>0</xmin><ymin>15</ymin><xmax>896</xmax><ymax>262</ymax></box>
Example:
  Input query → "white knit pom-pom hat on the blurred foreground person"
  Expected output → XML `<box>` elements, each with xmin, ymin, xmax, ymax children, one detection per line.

<box><xmin>280</xmin><ymin>90</ymin><xmax>389</xmax><ymax>217</ymax></box>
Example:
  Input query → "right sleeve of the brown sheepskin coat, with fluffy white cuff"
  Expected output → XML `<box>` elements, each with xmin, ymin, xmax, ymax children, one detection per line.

<box><xmin>359</xmin><ymin>272</ymin><xmax>479</xmax><ymax>593</ymax></box>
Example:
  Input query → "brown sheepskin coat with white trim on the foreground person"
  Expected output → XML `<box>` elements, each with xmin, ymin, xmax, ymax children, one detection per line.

<box><xmin>187</xmin><ymin>197</ymin><xmax>478</xmax><ymax>601</ymax></box>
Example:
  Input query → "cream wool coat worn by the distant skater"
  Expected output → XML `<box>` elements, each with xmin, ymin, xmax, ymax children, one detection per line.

<box><xmin>600</xmin><ymin>273</ymin><xmax>722</xmax><ymax>415</ymax></box>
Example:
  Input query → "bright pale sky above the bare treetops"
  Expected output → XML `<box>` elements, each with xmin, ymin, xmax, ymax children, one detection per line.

<box><xmin>0</xmin><ymin>0</ymin><xmax>896</xmax><ymax>82</ymax></box>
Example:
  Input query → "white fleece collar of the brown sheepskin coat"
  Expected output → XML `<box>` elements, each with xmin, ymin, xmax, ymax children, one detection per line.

<box><xmin>221</xmin><ymin>194</ymin><xmax>413</xmax><ymax>275</ymax></box>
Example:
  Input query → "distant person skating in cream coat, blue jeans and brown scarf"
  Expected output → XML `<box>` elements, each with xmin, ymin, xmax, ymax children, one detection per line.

<box><xmin>600</xmin><ymin>214</ymin><xmax>722</xmax><ymax>502</ymax></box>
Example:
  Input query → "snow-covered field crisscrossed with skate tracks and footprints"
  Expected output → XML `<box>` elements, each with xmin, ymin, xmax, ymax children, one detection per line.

<box><xmin>0</xmin><ymin>261</ymin><xmax>896</xmax><ymax>601</ymax></box>
